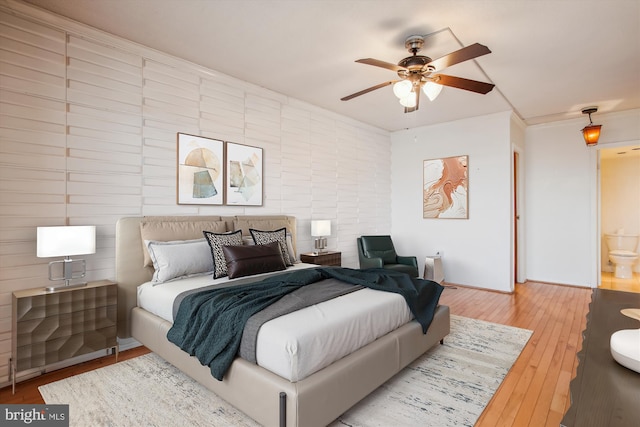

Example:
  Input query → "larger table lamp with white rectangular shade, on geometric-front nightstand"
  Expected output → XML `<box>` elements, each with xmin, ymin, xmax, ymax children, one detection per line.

<box><xmin>37</xmin><ymin>225</ymin><xmax>96</xmax><ymax>291</ymax></box>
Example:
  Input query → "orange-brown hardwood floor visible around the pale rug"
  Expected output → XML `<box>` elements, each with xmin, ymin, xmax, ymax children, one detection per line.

<box><xmin>0</xmin><ymin>282</ymin><xmax>591</xmax><ymax>427</ymax></box>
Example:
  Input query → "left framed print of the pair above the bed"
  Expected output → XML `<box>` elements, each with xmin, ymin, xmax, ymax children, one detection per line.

<box><xmin>177</xmin><ymin>133</ymin><xmax>224</xmax><ymax>205</ymax></box>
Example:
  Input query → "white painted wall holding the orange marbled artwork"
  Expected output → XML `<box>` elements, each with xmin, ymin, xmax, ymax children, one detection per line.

<box><xmin>391</xmin><ymin>112</ymin><xmax>513</xmax><ymax>292</ymax></box>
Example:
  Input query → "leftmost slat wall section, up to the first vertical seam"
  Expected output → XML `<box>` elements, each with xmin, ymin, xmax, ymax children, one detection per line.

<box><xmin>0</xmin><ymin>10</ymin><xmax>66</xmax><ymax>379</ymax></box>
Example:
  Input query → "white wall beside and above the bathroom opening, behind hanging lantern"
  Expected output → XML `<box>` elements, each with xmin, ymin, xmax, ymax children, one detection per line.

<box><xmin>525</xmin><ymin>110</ymin><xmax>640</xmax><ymax>287</ymax></box>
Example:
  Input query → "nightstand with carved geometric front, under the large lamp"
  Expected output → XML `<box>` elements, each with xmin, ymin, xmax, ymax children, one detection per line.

<box><xmin>11</xmin><ymin>280</ymin><xmax>119</xmax><ymax>391</ymax></box>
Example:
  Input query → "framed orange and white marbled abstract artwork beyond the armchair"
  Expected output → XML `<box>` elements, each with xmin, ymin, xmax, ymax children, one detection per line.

<box><xmin>422</xmin><ymin>156</ymin><xmax>469</xmax><ymax>219</ymax></box>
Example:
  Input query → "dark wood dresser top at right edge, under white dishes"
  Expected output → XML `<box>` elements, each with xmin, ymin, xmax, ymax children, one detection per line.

<box><xmin>561</xmin><ymin>289</ymin><xmax>640</xmax><ymax>427</ymax></box>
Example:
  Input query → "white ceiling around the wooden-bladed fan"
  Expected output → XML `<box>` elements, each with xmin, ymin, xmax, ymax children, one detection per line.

<box><xmin>20</xmin><ymin>0</ymin><xmax>640</xmax><ymax>131</ymax></box>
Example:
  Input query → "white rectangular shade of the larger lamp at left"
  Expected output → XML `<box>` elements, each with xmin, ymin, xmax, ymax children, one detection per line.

<box><xmin>37</xmin><ymin>225</ymin><xmax>96</xmax><ymax>258</ymax></box>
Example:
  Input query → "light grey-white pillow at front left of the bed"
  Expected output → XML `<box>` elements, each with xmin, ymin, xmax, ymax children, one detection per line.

<box><xmin>144</xmin><ymin>238</ymin><xmax>213</xmax><ymax>285</ymax></box>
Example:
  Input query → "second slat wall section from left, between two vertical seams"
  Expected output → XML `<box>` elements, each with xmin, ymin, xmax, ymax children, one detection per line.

<box><xmin>66</xmin><ymin>35</ymin><xmax>142</xmax><ymax>294</ymax></box>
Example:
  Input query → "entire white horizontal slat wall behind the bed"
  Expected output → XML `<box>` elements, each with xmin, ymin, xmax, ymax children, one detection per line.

<box><xmin>0</xmin><ymin>4</ymin><xmax>391</xmax><ymax>384</ymax></box>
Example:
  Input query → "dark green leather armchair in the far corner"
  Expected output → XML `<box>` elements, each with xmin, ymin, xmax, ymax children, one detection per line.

<box><xmin>357</xmin><ymin>236</ymin><xmax>418</xmax><ymax>277</ymax></box>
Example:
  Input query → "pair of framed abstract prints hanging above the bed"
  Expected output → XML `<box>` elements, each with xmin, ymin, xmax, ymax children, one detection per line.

<box><xmin>177</xmin><ymin>133</ymin><xmax>263</xmax><ymax>206</ymax></box>
